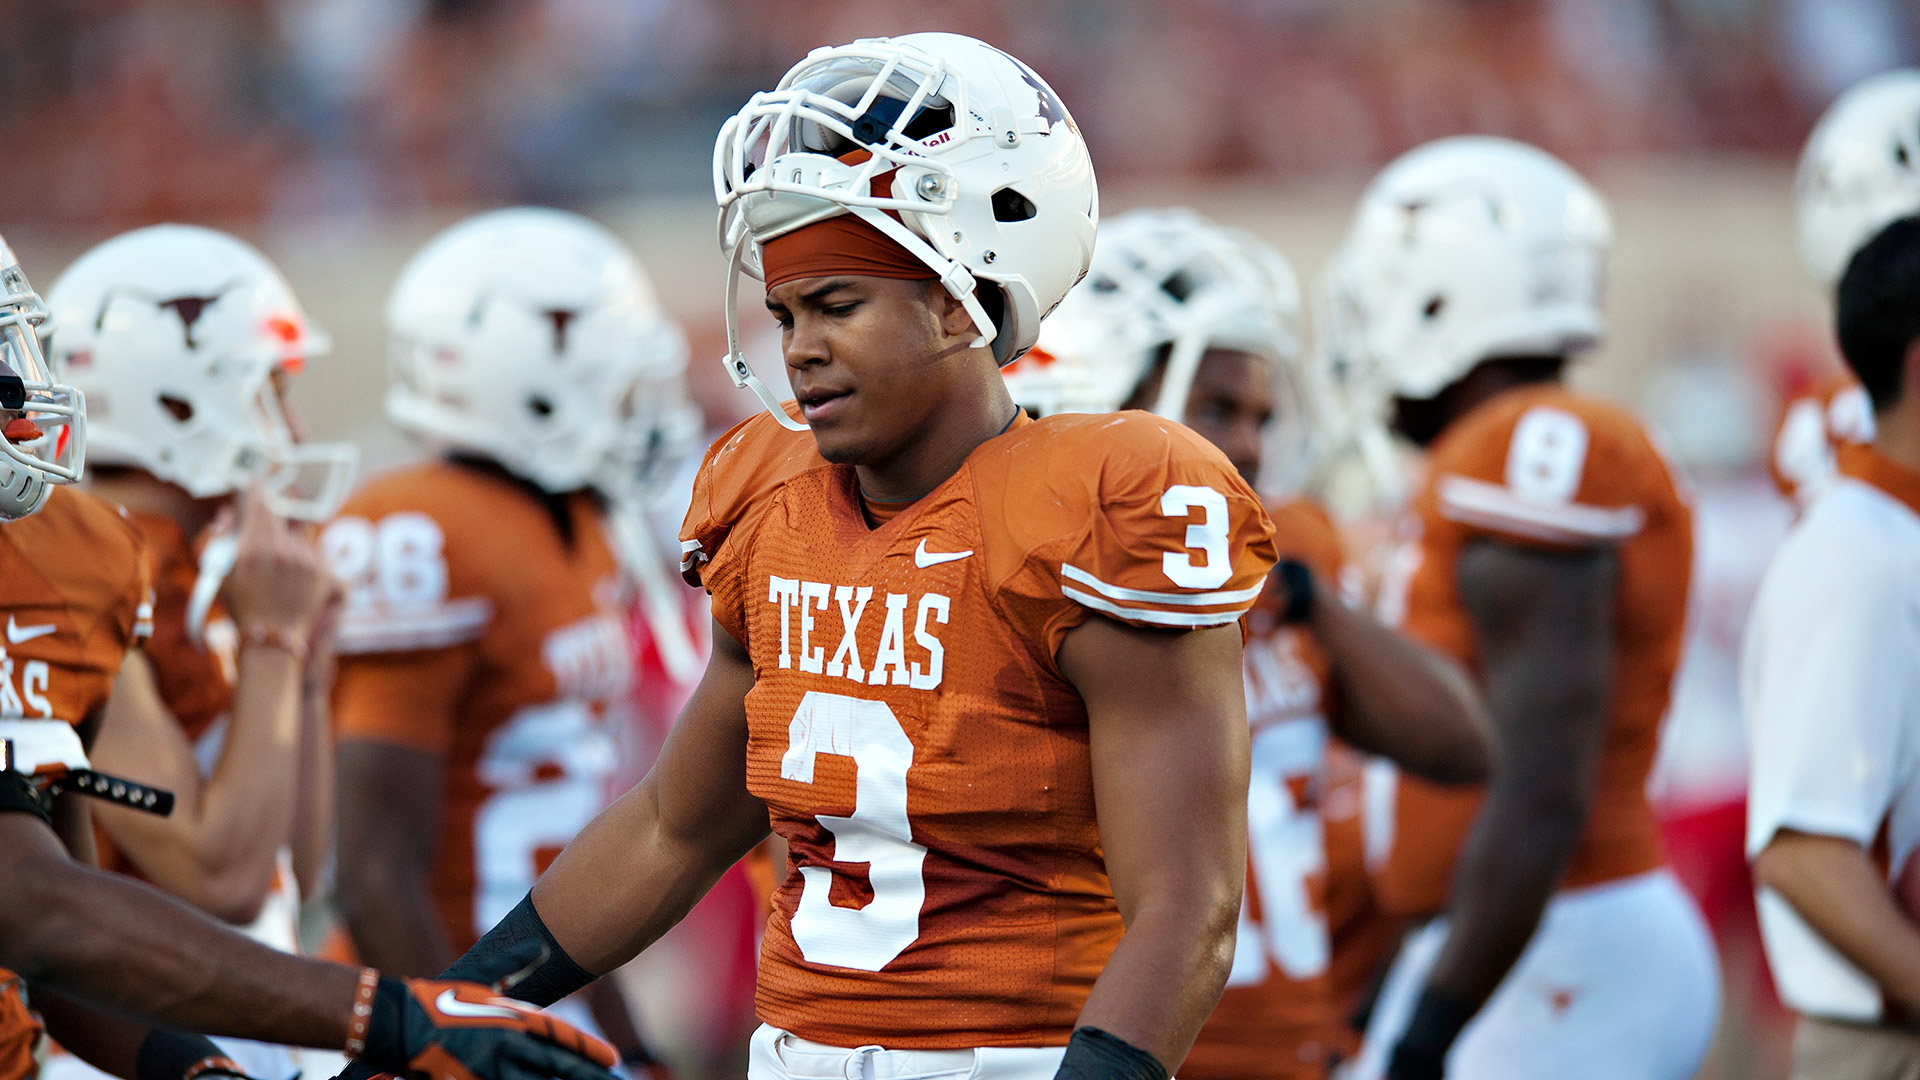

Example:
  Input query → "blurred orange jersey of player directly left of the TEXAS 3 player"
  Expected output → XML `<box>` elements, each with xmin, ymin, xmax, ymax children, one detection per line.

<box><xmin>321</xmin><ymin>463</ymin><xmax>634</xmax><ymax>949</ymax></box>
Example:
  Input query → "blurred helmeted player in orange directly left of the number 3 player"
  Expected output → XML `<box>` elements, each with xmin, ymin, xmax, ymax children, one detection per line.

<box><xmin>321</xmin><ymin>208</ymin><xmax>691</xmax><ymax>1065</ymax></box>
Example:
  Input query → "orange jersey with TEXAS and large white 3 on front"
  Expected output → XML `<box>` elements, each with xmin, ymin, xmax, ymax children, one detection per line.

<box><xmin>682</xmin><ymin>403</ymin><xmax>1273</xmax><ymax>1049</ymax></box>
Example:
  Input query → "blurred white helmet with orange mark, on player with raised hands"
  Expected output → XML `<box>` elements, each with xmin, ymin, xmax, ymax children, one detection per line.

<box><xmin>48</xmin><ymin>225</ymin><xmax>359</xmax><ymax>521</ymax></box>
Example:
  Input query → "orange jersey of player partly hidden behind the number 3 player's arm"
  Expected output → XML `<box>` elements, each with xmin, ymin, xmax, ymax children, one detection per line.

<box><xmin>1179</xmin><ymin>500</ymin><xmax>1344</xmax><ymax>1080</ymax></box>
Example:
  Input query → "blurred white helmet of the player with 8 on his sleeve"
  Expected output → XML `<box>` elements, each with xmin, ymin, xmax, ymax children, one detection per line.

<box><xmin>1327</xmin><ymin>136</ymin><xmax>1613</xmax><ymax>404</ymax></box>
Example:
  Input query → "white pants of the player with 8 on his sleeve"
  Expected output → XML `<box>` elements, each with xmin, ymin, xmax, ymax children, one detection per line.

<box><xmin>1346</xmin><ymin>869</ymin><xmax>1720</xmax><ymax>1080</ymax></box>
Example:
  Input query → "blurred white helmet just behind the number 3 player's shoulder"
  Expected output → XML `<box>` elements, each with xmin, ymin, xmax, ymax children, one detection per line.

<box><xmin>1006</xmin><ymin>209</ymin><xmax>1319</xmax><ymax>488</ymax></box>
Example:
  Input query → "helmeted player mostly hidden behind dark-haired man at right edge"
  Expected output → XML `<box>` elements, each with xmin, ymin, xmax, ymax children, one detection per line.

<box><xmin>1772</xmin><ymin>67</ymin><xmax>1920</xmax><ymax>507</ymax></box>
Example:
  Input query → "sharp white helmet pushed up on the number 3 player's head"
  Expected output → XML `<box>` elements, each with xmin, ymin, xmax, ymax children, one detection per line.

<box><xmin>714</xmin><ymin>33</ymin><xmax>1100</xmax><ymax>430</ymax></box>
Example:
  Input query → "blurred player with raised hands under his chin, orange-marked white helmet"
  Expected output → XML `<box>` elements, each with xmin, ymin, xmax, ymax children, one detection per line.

<box><xmin>36</xmin><ymin>225</ymin><xmax>355</xmax><ymax>1076</ymax></box>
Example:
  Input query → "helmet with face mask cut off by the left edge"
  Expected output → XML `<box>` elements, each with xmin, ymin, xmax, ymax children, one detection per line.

<box><xmin>0</xmin><ymin>238</ymin><xmax>86</xmax><ymax>521</ymax></box>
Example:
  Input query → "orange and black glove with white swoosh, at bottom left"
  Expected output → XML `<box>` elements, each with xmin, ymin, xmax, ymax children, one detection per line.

<box><xmin>348</xmin><ymin>969</ymin><xmax>620</xmax><ymax>1080</ymax></box>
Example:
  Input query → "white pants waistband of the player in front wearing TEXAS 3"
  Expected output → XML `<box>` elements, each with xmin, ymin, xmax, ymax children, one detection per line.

<box><xmin>747</xmin><ymin>1024</ymin><xmax>1066</xmax><ymax>1080</ymax></box>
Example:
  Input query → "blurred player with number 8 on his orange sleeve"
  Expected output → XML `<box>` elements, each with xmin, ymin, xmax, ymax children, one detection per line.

<box><xmin>1329</xmin><ymin>138</ymin><xmax>1718</xmax><ymax>1080</ymax></box>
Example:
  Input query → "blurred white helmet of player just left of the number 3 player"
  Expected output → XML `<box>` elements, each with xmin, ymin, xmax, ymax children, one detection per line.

<box><xmin>386</xmin><ymin>208</ymin><xmax>685</xmax><ymax>496</ymax></box>
